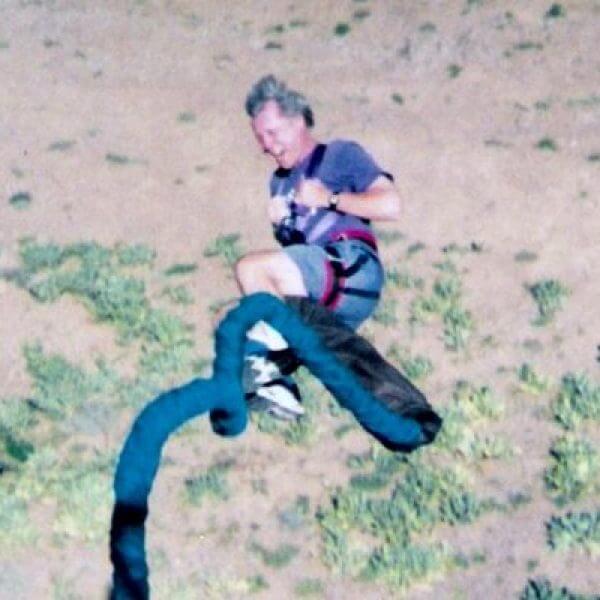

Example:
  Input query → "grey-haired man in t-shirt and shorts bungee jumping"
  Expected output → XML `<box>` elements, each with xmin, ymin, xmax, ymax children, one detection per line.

<box><xmin>235</xmin><ymin>75</ymin><xmax>400</xmax><ymax>418</ymax></box>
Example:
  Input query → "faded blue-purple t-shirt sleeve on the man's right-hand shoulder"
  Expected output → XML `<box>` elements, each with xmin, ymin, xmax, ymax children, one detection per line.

<box><xmin>319</xmin><ymin>140</ymin><xmax>393</xmax><ymax>192</ymax></box>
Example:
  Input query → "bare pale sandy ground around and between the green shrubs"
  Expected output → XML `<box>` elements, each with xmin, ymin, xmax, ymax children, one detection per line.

<box><xmin>0</xmin><ymin>0</ymin><xmax>600</xmax><ymax>599</ymax></box>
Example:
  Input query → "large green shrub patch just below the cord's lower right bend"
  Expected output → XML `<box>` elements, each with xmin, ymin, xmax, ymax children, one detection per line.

<box><xmin>317</xmin><ymin>450</ymin><xmax>493</xmax><ymax>587</ymax></box>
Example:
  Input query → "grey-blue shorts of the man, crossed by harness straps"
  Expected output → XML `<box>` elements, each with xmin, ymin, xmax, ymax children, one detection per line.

<box><xmin>283</xmin><ymin>240</ymin><xmax>385</xmax><ymax>329</ymax></box>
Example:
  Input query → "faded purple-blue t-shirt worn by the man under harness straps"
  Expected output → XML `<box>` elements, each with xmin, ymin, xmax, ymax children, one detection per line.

<box><xmin>270</xmin><ymin>140</ymin><xmax>391</xmax><ymax>246</ymax></box>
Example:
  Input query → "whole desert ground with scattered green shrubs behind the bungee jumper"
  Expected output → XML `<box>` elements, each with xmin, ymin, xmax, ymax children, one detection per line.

<box><xmin>0</xmin><ymin>0</ymin><xmax>600</xmax><ymax>600</ymax></box>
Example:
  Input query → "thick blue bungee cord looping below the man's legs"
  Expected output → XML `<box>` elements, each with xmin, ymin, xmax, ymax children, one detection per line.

<box><xmin>110</xmin><ymin>292</ymin><xmax>431</xmax><ymax>600</ymax></box>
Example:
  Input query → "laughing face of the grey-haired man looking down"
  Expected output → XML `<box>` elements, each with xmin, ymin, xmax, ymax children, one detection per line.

<box><xmin>252</xmin><ymin>100</ymin><xmax>306</xmax><ymax>169</ymax></box>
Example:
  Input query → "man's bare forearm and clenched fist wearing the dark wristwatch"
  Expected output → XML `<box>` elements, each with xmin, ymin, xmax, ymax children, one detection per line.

<box><xmin>296</xmin><ymin>175</ymin><xmax>402</xmax><ymax>221</ymax></box>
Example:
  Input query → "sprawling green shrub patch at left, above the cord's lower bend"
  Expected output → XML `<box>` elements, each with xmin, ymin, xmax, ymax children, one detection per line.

<box><xmin>13</xmin><ymin>238</ymin><xmax>196</xmax><ymax>398</ymax></box>
